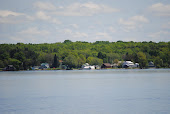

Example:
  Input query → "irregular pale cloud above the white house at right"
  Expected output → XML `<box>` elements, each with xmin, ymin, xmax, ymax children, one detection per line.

<box><xmin>118</xmin><ymin>15</ymin><xmax>149</xmax><ymax>32</ymax></box>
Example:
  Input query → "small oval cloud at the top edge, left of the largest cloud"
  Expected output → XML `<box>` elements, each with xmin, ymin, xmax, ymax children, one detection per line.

<box><xmin>34</xmin><ymin>1</ymin><xmax>56</xmax><ymax>10</ymax></box>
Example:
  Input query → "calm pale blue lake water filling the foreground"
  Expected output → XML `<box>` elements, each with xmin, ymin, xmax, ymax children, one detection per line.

<box><xmin>0</xmin><ymin>69</ymin><xmax>170</xmax><ymax>114</ymax></box>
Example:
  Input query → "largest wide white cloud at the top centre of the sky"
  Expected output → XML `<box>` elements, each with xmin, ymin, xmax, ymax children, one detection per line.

<box><xmin>52</xmin><ymin>2</ymin><xmax>119</xmax><ymax>16</ymax></box>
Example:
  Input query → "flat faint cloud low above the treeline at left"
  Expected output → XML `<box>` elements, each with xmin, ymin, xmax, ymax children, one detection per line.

<box><xmin>19</xmin><ymin>27</ymin><xmax>50</xmax><ymax>36</ymax></box>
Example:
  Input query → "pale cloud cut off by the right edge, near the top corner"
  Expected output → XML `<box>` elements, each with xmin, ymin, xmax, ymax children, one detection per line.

<box><xmin>148</xmin><ymin>3</ymin><xmax>170</xmax><ymax>16</ymax></box>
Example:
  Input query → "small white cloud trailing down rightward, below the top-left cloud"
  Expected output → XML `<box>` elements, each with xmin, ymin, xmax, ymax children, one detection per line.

<box><xmin>36</xmin><ymin>11</ymin><xmax>61</xmax><ymax>24</ymax></box>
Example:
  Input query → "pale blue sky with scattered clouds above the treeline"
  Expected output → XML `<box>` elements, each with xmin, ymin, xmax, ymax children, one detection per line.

<box><xmin>0</xmin><ymin>0</ymin><xmax>170</xmax><ymax>44</ymax></box>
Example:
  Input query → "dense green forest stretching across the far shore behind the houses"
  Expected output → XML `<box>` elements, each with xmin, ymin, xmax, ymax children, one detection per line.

<box><xmin>0</xmin><ymin>40</ymin><xmax>170</xmax><ymax>70</ymax></box>
